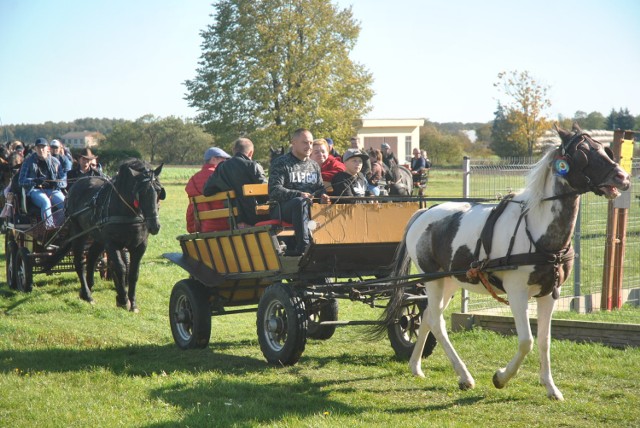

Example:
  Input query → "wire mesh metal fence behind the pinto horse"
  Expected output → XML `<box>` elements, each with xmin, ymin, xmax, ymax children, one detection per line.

<box><xmin>463</xmin><ymin>155</ymin><xmax>640</xmax><ymax>312</ymax></box>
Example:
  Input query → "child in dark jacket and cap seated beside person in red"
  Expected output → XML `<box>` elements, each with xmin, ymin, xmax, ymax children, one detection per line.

<box><xmin>331</xmin><ymin>149</ymin><xmax>369</xmax><ymax>204</ymax></box>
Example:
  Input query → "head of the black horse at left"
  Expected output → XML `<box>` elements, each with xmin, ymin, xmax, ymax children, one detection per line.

<box><xmin>118</xmin><ymin>159</ymin><xmax>166</xmax><ymax>235</ymax></box>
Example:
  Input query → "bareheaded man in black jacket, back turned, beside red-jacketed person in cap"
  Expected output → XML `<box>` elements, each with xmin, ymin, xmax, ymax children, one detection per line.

<box><xmin>203</xmin><ymin>138</ymin><xmax>267</xmax><ymax>229</ymax></box>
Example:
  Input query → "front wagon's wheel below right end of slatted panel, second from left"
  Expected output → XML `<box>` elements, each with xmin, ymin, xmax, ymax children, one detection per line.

<box><xmin>256</xmin><ymin>283</ymin><xmax>307</xmax><ymax>366</ymax></box>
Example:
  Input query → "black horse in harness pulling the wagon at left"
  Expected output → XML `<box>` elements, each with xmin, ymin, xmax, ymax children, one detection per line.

<box><xmin>48</xmin><ymin>159</ymin><xmax>166</xmax><ymax>312</ymax></box>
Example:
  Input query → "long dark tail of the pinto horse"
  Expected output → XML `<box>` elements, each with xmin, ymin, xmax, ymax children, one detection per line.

<box><xmin>372</xmin><ymin>210</ymin><xmax>424</xmax><ymax>337</ymax></box>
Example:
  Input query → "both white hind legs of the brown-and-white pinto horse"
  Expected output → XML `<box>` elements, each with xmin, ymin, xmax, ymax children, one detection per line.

<box><xmin>409</xmin><ymin>278</ymin><xmax>475</xmax><ymax>390</ymax></box>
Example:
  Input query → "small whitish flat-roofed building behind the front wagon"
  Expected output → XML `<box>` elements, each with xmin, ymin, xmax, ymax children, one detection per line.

<box><xmin>357</xmin><ymin>119</ymin><xmax>424</xmax><ymax>162</ymax></box>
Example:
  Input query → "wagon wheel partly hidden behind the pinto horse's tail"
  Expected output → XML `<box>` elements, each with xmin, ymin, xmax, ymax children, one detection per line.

<box><xmin>387</xmin><ymin>294</ymin><xmax>438</xmax><ymax>360</ymax></box>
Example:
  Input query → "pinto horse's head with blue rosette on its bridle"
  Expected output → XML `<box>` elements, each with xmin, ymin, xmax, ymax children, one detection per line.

<box><xmin>554</xmin><ymin>125</ymin><xmax>630</xmax><ymax>199</ymax></box>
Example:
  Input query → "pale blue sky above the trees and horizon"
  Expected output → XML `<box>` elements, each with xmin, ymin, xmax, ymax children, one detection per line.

<box><xmin>0</xmin><ymin>0</ymin><xmax>640</xmax><ymax>124</ymax></box>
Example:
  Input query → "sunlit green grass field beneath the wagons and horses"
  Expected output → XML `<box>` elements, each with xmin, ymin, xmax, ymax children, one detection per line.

<box><xmin>0</xmin><ymin>168</ymin><xmax>640</xmax><ymax>427</ymax></box>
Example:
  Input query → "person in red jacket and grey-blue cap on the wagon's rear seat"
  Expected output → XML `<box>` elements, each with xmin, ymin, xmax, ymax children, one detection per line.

<box><xmin>184</xmin><ymin>147</ymin><xmax>231</xmax><ymax>233</ymax></box>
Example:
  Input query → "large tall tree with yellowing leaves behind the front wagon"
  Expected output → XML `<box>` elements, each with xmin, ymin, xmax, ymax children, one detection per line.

<box><xmin>185</xmin><ymin>0</ymin><xmax>373</xmax><ymax>157</ymax></box>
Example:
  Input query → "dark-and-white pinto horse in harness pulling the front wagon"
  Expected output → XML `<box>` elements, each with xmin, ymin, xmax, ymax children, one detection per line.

<box><xmin>385</xmin><ymin>125</ymin><xmax>629</xmax><ymax>400</ymax></box>
